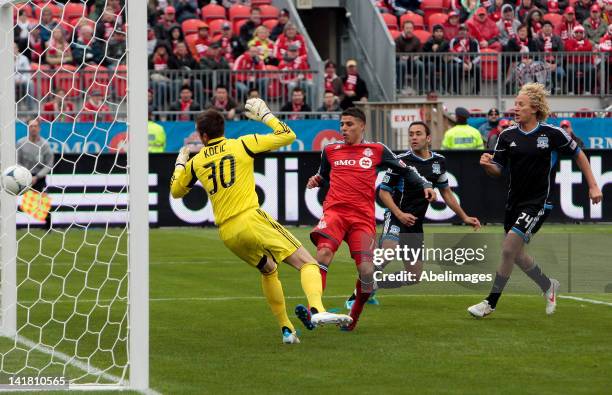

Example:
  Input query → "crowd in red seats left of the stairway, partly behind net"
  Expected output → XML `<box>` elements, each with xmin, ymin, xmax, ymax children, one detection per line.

<box><xmin>15</xmin><ymin>0</ymin><xmax>368</xmax><ymax>121</ymax></box>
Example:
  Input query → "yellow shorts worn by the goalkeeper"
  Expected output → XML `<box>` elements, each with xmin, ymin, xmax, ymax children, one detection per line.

<box><xmin>219</xmin><ymin>209</ymin><xmax>302</xmax><ymax>267</ymax></box>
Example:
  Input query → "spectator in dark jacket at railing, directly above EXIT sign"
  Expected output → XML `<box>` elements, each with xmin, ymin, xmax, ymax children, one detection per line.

<box><xmin>395</xmin><ymin>21</ymin><xmax>425</xmax><ymax>95</ymax></box>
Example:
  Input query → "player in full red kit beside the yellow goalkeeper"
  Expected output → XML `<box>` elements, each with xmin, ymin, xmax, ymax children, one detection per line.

<box><xmin>296</xmin><ymin>107</ymin><xmax>436</xmax><ymax>330</ymax></box>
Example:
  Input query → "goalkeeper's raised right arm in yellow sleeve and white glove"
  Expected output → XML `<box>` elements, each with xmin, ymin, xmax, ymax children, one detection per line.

<box><xmin>240</xmin><ymin>99</ymin><xmax>297</xmax><ymax>156</ymax></box>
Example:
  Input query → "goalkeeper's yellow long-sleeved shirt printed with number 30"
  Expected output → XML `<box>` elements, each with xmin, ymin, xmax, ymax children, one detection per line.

<box><xmin>170</xmin><ymin>118</ymin><xmax>296</xmax><ymax>225</ymax></box>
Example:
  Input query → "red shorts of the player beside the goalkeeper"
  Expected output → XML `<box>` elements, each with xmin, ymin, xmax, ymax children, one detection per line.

<box><xmin>310</xmin><ymin>208</ymin><xmax>376</xmax><ymax>263</ymax></box>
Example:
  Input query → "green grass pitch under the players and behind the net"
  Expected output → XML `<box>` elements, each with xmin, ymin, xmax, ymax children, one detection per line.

<box><xmin>0</xmin><ymin>225</ymin><xmax>612</xmax><ymax>394</ymax></box>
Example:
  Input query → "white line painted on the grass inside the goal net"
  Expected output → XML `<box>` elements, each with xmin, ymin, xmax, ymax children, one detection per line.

<box><xmin>2</xmin><ymin>335</ymin><xmax>161</xmax><ymax>395</ymax></box>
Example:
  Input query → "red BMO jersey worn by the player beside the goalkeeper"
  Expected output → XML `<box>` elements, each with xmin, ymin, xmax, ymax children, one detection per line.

<box><xmin>319</xmin><ymin>142</ymin><xmax>431</xmax><ymax>221</ymax></box>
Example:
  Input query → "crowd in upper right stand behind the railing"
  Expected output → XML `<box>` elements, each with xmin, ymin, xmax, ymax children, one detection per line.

<box><xmin>382</xmin><ymin>0</ymin><xmax>612</xmax><ymax>95</ymax></box>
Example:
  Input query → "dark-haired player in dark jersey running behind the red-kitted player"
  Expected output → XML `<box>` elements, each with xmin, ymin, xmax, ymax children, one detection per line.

<box><xmin>347</xmin><ymin>121</ymin><xmax>480</xmax><ymax>307</ymax></box>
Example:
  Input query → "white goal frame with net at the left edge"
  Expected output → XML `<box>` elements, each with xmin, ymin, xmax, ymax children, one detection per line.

<box><xmin>0</xmin><ymin>0</ymin><xmax>154</xmax><ymax>393</ymax></box>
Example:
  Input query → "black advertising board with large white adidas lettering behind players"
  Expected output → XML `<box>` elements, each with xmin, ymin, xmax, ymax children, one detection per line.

<box><xmin>17</xmin><ymin>150</ymin><xmax>612</xmax><ymax>226</ymax></box>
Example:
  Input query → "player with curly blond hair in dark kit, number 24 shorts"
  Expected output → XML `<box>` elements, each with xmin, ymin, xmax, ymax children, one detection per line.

<box><xmin>468</xmin><ymin>83</ymin><xmax>602</xmax><ymax>317</ymax></box>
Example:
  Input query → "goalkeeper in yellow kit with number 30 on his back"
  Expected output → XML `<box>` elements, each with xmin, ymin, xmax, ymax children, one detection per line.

<box><xmin>170</xmin><ymin>99</ymin><xmax>352</xmax><ymax>343</ymax></box>
